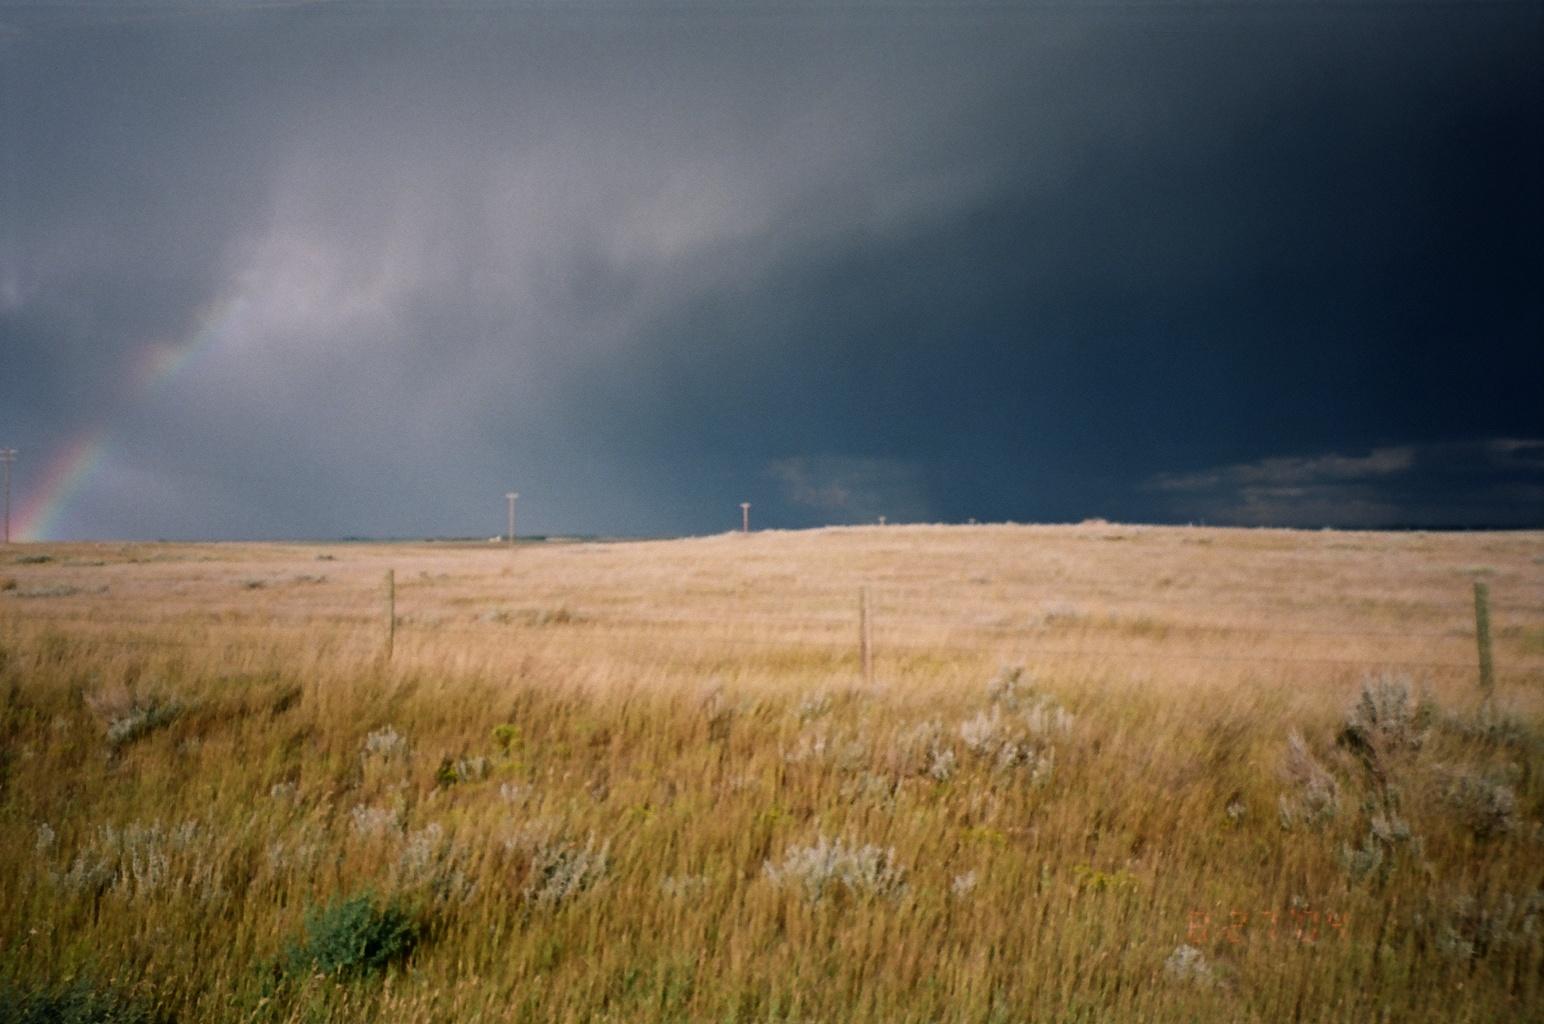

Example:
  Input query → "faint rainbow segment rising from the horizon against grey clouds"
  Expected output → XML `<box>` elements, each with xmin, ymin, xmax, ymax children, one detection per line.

<box><xmin>12</xmin><ymin>297</ymin><xmax>245</xmax><ymax>541</ymax></box>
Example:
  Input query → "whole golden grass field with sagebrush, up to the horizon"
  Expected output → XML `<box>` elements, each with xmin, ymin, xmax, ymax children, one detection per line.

<box><xmin>0</xmin><ymin>524</ymin><xmax>1544</xmax><ymax>1024</ymax></box>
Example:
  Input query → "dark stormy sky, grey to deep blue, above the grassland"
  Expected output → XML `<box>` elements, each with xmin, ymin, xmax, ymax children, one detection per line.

<box><xmin>0</xmin><ymin>0</ymin><xmax>1544</xmax><ymax>539</ymax></box>
